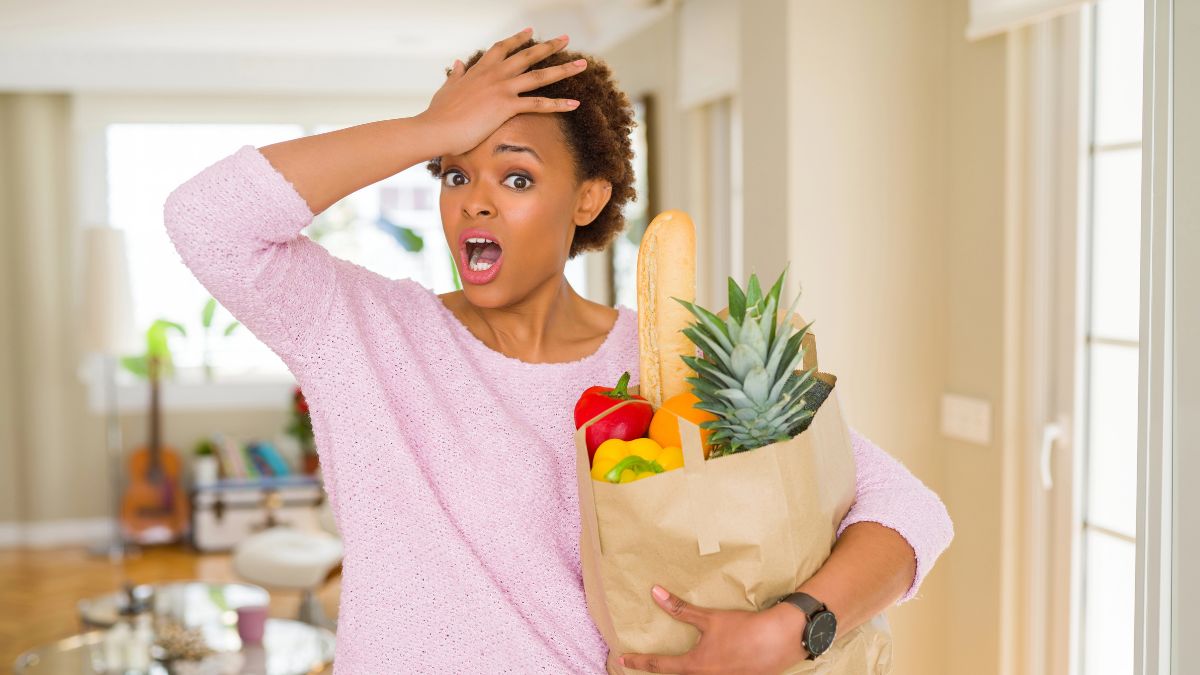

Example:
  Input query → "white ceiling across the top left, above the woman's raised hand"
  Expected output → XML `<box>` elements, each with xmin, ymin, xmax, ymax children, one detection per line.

<box><xmin>0</xmin><ymin>0</ymin><xmax>674</xmax><ymax>92</ymax></box>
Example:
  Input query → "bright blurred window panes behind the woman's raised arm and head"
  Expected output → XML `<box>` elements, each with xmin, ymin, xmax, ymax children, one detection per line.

<box><xmin>104</xmin><ymin>123</ymin><xmax>588</xmax><ymax>382</ymax></box>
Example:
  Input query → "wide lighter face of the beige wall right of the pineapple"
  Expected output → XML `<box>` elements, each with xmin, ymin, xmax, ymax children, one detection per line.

<box><xmin>787</xmin><ymin>5</ymin><xmax>958</xmax><ymax>675</ymax></box>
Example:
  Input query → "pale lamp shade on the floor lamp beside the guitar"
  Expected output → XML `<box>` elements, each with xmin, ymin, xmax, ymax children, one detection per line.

<box><xmin>82</xmin><ymin>227</ymin><xmax>145</xmax><ymax>356</ymax></box>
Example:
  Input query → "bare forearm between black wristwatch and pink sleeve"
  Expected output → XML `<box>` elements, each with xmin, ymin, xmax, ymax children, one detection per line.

<box><xmin>797</xmin><ymin>521</ymin><xmax>917</xmax><ymax>634</ymax></box>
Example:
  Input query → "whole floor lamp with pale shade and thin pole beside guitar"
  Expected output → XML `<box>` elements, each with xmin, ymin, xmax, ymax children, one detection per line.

<box><xmin>83</xmin><ymin>226</ymin><xmax>145</xmax><ymax>562</ymax></box>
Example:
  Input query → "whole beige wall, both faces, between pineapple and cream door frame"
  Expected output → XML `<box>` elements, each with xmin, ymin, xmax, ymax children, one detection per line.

<box><xmin>790</xmin><ymin>0</ymin><xmax>1006</xmax><ymax>674</ymax></box>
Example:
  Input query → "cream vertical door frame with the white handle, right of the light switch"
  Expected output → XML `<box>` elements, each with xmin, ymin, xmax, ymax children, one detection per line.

<box><xmin>1000</xmin><ymin>12</ymin><xmax>1087</xmax><ymax>675</ymax></box>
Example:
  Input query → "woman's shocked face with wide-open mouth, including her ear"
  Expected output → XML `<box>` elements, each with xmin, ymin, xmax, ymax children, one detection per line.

<box><xmin>439</xmin><ymin>113</ymin><xmax>611</xmax><ymax>307</ymax></box>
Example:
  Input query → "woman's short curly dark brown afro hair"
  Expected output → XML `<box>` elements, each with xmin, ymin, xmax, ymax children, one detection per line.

<box><xmin>425</xmin><ymin>38</ymin><xmax>637</xmax><ymax>258</ymax></box>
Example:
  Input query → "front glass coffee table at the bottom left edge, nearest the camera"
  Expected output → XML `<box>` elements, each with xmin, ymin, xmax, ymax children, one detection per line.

<box><xmin>13</xmin><ymin>619</ymin><xmax>334</xmax><ymax>675</ymax></box>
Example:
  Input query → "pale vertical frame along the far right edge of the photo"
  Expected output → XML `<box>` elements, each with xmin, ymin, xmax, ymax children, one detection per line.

<box><xmin>1134</xmin><ymin>0</ymin><xmax>1200</xmax><ymax>675</ymax></box>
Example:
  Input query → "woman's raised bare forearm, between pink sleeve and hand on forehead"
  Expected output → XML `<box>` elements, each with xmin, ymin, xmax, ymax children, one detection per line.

<box><xmin>258</xmin><ymin>115</ymin><xmax>440</xmax><ymax>214</ymax></box>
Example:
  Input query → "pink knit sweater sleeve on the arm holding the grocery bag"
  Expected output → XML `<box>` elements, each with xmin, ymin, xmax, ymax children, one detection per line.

<box><xmin>838</xmin><ymin>429</ymin><xmax>954</xmax><ymax>604</ymax></box>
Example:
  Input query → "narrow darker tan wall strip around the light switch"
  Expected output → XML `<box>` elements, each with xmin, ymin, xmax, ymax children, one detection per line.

<box><xmin>942</xmin><ymin>0</ymin><xmax>1007</xmax><ymax>674</ymax></box>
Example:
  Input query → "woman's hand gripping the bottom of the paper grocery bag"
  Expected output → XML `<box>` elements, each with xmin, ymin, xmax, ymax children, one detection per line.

<box><xmin>620</xmin><ymin>586</ymin><xmax>809</xmax><ymax>675</ymax></box>
